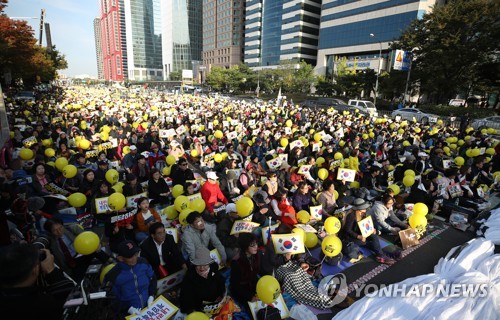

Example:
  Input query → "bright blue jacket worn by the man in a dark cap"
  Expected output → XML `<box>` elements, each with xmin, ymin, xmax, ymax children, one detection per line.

<box><xmin>104</xmin><ymin>257</ymin><xmax>157</xmax><ymax>310</ymax></box>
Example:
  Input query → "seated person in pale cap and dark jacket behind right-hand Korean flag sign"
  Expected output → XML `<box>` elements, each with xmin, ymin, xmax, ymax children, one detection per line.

<box><xmin>341</xmin><ymin>198</ymin><xmax>395</xmax><ymax>265</ymax></box>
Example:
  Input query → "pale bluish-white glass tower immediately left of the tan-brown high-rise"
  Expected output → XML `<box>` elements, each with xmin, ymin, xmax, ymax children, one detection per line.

<box><xmin>161</xmin><ymin>0</ymin><xmax>203</xmax><ymax>79</ymax></box>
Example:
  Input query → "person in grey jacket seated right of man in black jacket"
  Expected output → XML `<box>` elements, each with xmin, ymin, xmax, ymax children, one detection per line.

<box><xmin>182</xmin><ymin>211</ymin><xmax>227</xmax><ymax>265</ymax></box>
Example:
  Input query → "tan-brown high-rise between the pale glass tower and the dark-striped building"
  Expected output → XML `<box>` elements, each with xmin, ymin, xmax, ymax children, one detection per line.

<box><xmin>203</xmin><ymin>0</ymin><xmax>245</xmax><ymax>68</ymax></box>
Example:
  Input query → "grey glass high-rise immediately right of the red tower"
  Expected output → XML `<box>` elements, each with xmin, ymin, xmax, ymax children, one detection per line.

<box><xmin>124</xmin><ymin>0</ymin><xmax>163</xmax><ymax>81</ymax></box>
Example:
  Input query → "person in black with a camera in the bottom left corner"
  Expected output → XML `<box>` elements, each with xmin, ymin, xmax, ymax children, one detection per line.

<box><xmin>0</xmin><ymin>244</ymin><xmax>74</xmax><ymax>319</ymax></box>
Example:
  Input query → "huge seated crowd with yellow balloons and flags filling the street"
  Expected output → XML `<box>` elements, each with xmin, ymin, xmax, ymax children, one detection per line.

<box><xmin>0</xmin><ymin>87</ymin><xmax>500</xmax><ymax>319</ymax></box>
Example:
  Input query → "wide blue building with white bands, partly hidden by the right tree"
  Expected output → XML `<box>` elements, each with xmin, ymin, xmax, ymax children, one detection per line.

<box><xmin>316</xmin><ymin>0</ymin><xmax>444</xmax><ymax>79</ymax></box>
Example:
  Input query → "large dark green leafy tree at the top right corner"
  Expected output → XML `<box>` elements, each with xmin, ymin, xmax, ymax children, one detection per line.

<box><xmin>392</xmin><ymin>0</ymin><xmax>500</xmax><ymax>103</ymax></box>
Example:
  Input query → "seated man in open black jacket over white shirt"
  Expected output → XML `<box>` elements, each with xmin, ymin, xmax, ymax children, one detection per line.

<box><xmin>140</xmin><ymin>222</ymin><xmax>187</xmax><ymax>279</ymax></box>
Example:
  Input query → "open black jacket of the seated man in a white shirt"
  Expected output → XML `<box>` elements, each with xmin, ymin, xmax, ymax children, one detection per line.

<box><xmin>141</xmin><ymin>234</ymin><xmax>186</xmax><ymax>279</ymax></box>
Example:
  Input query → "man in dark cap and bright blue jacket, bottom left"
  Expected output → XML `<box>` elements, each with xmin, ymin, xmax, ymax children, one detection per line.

<box><xmin>103</xmin><ymin>240</ymin><xmax>157</xmax><ymax>315</ymax></box>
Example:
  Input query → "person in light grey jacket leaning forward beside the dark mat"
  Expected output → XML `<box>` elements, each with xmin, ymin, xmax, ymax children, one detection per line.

<box><xmin>366</xmin><ymin>194</ymin><xmax>409</xmax><ymax>236</ymax></box>
